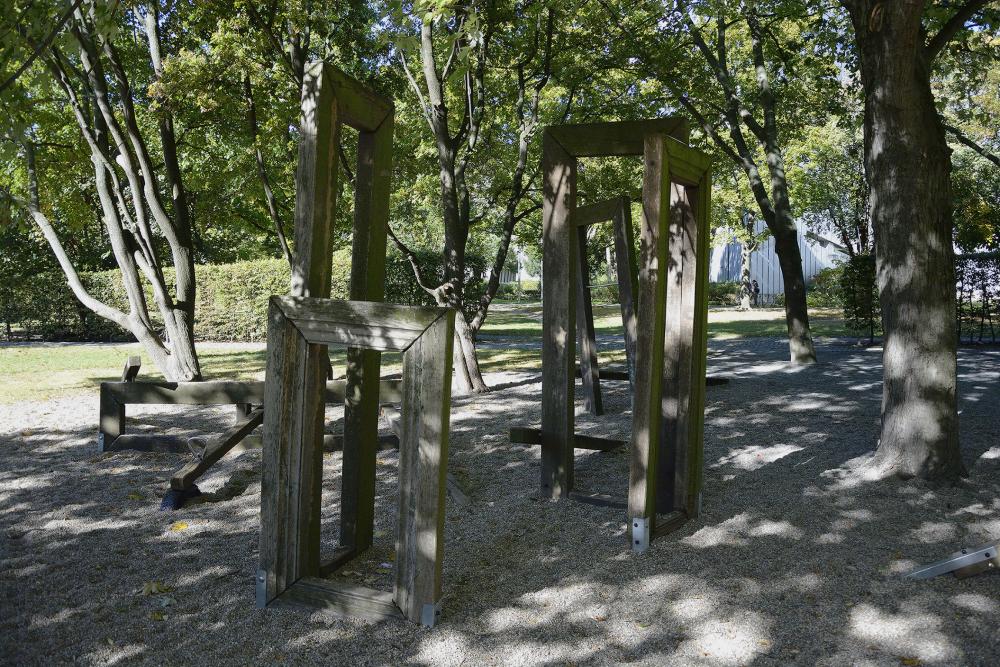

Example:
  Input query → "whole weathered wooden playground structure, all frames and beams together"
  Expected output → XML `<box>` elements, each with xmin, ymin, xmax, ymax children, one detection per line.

<box><xmin>99</xmin><ymin>62</ymin><xmax>711</xmax><ymax>626</ymax></box>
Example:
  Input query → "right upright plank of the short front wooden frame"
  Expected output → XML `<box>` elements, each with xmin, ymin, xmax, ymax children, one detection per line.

<box><xmin>393</xmin><ymin>310</ymin><xmax>455</xmax><ymax>625</ymax></box>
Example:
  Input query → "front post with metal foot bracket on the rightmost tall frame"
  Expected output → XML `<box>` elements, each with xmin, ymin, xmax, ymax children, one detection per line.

<box><xmin>628</xmin><ymin>136</ymin><xmax>670</xmax><ymax>541</ymax></box>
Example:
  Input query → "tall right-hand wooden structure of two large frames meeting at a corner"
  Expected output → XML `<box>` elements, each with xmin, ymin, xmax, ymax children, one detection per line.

<box><xmin>540</xmin><ymin>118</ymin><xmax>711</xmax><ymax>551</ymax></box>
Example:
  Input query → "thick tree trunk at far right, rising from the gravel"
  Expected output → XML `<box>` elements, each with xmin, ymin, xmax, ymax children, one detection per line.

<box><xmin>850</xmin><ymin>2</ymin><xmax>964</xmax><ymax>480</ymax></box>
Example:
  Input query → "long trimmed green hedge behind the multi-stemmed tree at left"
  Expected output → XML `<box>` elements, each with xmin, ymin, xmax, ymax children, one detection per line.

<box><xmin>0</xmin><ymin>248</ymin><xmax>485</xmax><ymax>342</ymax></box>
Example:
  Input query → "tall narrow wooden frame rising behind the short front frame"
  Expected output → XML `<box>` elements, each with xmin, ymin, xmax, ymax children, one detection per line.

<box><xmin>290</xmin><ymin>61</ymin><xmax>394</xmax><ymax>552</ymax></box>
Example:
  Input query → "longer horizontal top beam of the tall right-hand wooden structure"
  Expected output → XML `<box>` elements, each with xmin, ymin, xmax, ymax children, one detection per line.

<box><xmin>545</xmin><ymin>116</ymin><xmax>690</xmax><ymax>158</ymax></box>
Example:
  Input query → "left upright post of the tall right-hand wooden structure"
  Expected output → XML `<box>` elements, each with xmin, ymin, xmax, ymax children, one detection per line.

<box><xmin>541</xmin><ymin>127</ymin><xmax>577</xmax><ymax>498</ymax></box>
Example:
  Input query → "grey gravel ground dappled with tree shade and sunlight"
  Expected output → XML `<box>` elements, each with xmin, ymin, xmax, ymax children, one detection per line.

<box><xmin>0</xmin><ymin>339</ymin><xmax>1000</xmax><ymax>665</ymax></box>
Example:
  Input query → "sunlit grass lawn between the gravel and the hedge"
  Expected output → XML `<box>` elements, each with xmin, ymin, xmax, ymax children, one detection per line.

<box><xmin>0</xmin><ymin>305</ymin><xmax>849</xmax><ymax>404</ymax></box>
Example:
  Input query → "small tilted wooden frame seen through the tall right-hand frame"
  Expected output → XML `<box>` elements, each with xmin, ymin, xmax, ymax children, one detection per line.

<box><xmin>572</xmin><ymin>196</ymin><xmax>639</xmax><ymax>415</ymax></box>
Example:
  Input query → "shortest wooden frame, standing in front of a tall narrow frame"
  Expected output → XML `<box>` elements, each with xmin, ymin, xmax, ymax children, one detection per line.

<box><xmin>257</xmin><ymin>296</ymin><xmax>455</xmax><ymax>626</ymax></box>
